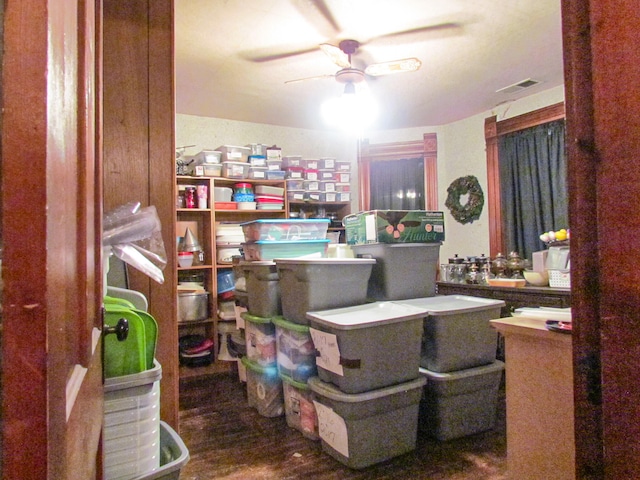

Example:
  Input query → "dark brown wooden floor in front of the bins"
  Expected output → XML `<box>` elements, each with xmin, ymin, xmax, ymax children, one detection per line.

<box><xmin>180</xmin><ymin>364</ymin><xmax>506</xmax><ymax>480</ymax></box>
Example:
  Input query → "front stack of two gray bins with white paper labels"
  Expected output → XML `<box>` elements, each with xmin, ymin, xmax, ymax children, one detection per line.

<box><xmin>307</xmin><ymin>302</ymin><xmax>426</xmax><ymax>469</ymax></box>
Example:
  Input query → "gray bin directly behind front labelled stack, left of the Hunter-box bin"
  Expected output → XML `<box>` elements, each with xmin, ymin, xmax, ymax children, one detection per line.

<box><xmin>275</xmin><ymin>258</ymin><xmax>375</xmax><ymax>325</ymax></box>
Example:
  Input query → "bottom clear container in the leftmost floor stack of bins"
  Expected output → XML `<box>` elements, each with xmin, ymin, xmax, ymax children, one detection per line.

<box><xmin>240</xmin><ymin>357</ymin><xmax>284</xmax><ymax>417</ymax></box>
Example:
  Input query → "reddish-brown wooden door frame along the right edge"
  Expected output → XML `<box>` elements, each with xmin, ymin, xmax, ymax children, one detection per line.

<box><xmin>562</xmin><ymin>0</ymin><xmax>640</xmax><ymax>479</ymax></box>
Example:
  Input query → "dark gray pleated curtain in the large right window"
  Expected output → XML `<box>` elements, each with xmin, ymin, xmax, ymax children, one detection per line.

<box><xmin>498</xmin><ymin>120</ymin><xmax>569</xmax><ymax>259</ymax></box>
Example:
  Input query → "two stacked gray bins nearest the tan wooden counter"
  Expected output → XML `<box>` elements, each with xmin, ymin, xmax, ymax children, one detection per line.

<box><xmin>397</xmin><ymin>295</ymin><xmax>505</xmax><ymax>440</ymax></box>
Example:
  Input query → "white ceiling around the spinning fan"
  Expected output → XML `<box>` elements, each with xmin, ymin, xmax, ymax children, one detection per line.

<box><xmin>175</xmin><ymin>0</ymin><xmax>563</xmax><ymax>129</ymax></box>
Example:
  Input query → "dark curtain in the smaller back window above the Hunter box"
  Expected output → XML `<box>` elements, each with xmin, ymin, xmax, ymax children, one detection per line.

<box><xmin>369</xmin><ymin>158</ymin><xmax>424</xmax><ymax>210</ymax></box>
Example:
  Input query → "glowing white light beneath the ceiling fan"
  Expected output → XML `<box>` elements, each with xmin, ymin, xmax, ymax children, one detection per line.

<box><xmin>321</xmin><ymin>82</ymin><xmax>378</xmax><ymax>133</ymax></box>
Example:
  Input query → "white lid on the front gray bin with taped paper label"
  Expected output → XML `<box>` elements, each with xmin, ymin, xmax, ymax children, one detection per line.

<box><xmin>306</xmin><ymin>300</ymin><xmax>427</xmax><ymax>330</ymax></box>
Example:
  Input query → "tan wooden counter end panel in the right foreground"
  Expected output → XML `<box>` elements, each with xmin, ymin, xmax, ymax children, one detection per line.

<box><xmin>491</xmin><ymin>317</ymin><xmax>575</xmax><ymax>480</ymax></box>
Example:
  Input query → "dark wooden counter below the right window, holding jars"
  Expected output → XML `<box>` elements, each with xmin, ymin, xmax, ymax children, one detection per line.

<box><xmin>436</xmin><ymin>282</ymin><xmax>571</xmax><ymax>317</ymax></box>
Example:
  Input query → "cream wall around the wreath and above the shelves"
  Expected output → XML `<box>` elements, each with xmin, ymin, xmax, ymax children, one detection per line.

<box><xmin>176</xmin><ymin>86</ymin><xmax>564</xmax><ymax>261</ymax></box>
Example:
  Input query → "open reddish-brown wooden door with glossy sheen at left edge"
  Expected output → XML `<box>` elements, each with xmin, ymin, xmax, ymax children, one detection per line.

<box><xmin>2</xmin><ymin>0</ymin><xmax>103</xmax><ymax>479</ymax></box>
